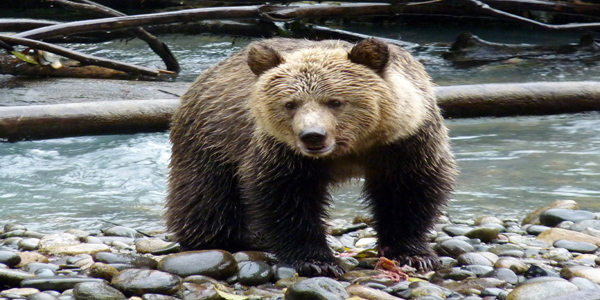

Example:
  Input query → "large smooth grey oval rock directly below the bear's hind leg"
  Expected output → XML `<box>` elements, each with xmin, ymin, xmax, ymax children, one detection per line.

<box><xmin>158</xmin><ymin>250</ymin><xmax>237</xmax><ymax>279</ymax></box>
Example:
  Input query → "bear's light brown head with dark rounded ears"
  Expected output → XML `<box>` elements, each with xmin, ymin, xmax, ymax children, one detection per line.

<box><xmin>248</xmin><ymin>39</ymin><xmax>424</xmax><ymax>158</ymax></box>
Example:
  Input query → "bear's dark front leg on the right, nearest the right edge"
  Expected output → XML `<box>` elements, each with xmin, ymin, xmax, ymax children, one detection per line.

<box><xmin>364</xmin><ymin>125</ymin><xmax>455</xmax><ymax>270</ymax></box>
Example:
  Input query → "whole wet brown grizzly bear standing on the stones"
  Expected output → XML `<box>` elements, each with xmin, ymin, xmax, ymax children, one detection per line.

<box><xmin>166</xmin><ymin>38</ymin><xmax>456</xmax><ymax>276</ymax></box>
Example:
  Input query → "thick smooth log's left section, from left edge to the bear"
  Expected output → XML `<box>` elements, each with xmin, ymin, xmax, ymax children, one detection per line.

<box><xmin>0</xmin><ymin>100</ymin><xmax>179</xmax><ymax>142</ymax></box>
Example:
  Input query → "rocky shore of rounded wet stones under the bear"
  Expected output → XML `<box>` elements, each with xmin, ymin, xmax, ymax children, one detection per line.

<box><xmin>0</xmin><ymin>200</ymin><xmax>600</xmax><ymax>300</ymax></box>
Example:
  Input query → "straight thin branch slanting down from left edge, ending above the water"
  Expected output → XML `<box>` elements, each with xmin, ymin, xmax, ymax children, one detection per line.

<box><xmin>0</xmin><ymin>34</ymin><xmax>175</xmax><ymax>77</ymax></box>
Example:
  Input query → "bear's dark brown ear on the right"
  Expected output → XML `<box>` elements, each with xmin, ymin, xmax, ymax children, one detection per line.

<box><xmin>348</xmin><ymin>38</ymin><xmax>390</xmax><ymax>73</ymax></box>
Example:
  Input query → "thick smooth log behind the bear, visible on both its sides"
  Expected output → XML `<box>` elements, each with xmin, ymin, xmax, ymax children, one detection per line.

<box><xmin>0</xmin><ymin>82</ymin><xmax>600</xmax><ymax>142</ymax></box>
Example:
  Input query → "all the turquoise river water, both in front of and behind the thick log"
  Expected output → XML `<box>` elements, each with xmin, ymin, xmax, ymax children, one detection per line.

<box><xmin>0</xmin><ymin>26</ymin><xmax>600</xmax><ymax>231</ymax></box>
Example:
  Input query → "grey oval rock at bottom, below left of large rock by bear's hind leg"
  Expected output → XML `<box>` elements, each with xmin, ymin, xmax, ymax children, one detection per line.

<box><xmin>111</xmin><ymin>269</ymin><xmax>182</xmax><ymax>296</ymax></box>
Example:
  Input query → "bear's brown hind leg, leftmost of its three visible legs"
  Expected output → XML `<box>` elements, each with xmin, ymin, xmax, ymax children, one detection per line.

<box><xmin>166</xmin><ymin>147</ymin><xmax>251</xmax><ymax>251</ymax></box>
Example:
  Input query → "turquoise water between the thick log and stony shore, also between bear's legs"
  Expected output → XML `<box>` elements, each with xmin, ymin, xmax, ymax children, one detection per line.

<box><xmin>0</xmin><ymin>114</ymin><xmax>600</xmax><ymax>231</ymax></box>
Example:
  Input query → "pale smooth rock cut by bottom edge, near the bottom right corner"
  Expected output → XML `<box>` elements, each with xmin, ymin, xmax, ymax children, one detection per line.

<box><xmin>507</xmin><ymin>277</ymin><xmax>579</xmax><ymax>300</ymax></box>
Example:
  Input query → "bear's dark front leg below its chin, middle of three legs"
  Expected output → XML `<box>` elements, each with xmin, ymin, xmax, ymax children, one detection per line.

<box><xmin>241</xmin><ymin>142</ymin><xmax>344</xmax><ymax>277</ymax></box>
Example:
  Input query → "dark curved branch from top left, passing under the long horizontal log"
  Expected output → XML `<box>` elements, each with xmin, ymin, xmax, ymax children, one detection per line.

<box><xmin>49</xmin><ymin>0</ymin><xmax>180</xmax><ymax>73</ymax></box>
